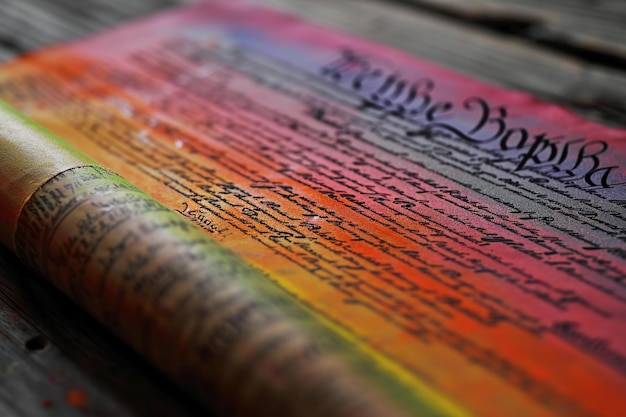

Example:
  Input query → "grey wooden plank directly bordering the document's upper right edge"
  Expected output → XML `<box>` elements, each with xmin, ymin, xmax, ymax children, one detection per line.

<box><xmin>257</xmin><ymin>0</ymin><xmax>626</xmax><ymax>126</ymax></box>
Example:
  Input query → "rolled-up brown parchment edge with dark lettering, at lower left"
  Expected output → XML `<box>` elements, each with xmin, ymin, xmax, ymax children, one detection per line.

<box><xmin>0</xmin><ymin>104</ymin><xmax>402</xmax><ymax>417</ymax></box>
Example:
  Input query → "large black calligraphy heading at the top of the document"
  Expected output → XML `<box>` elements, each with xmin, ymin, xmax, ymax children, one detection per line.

<box><xmin>321</xmin><ymin>50</ymin><xmax>626</xmax><ymax>188</ymax></box>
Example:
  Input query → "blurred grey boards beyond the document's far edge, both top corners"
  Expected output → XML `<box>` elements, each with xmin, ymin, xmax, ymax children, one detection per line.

<box><xmin>0</xmin><ymin>0</ymin><xmax>626</xmax><ymax>126</ymax></box>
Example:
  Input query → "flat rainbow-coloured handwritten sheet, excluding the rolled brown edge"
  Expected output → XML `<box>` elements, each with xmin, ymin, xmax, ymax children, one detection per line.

<box><xmin>0</xmin><ymin>1</ymin><xmax>626</xmax><ymax>417</ymax></box>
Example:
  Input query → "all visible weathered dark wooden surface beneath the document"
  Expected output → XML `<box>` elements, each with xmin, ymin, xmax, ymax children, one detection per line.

<box><xmin>0</xmin><ymin>0</ymin><xmax>626</xmax><ymax>416</ymax></box>
